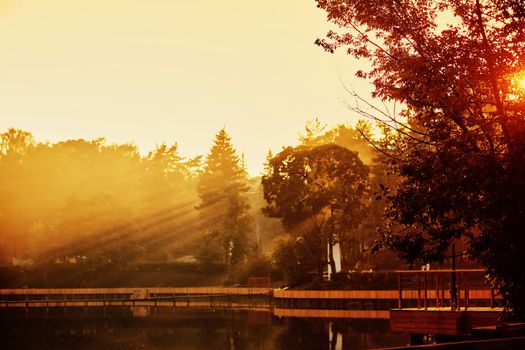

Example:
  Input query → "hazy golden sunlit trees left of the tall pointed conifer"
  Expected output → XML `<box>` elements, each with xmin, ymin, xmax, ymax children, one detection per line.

<box><xmin>0</xmin><ymin>129</ymin><xmax>197</xmax><ymax>265</ymax></box>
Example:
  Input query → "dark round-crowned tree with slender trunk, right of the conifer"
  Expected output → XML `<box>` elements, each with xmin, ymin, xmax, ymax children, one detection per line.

<box><xmin>262</xmin><ymin>144</ymin><xmax>368</xmax><ymax>277</ymax></box>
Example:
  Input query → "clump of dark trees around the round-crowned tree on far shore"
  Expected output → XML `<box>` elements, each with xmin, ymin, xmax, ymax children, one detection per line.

<box><xmin>262</xmin><ymin>119</ymin><xmax>404</xmax><ymax>285</ymax></box>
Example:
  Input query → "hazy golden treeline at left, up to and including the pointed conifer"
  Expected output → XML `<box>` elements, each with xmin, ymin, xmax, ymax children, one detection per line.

<box><xmin>0</xmin><ymin>129</ymin><xmax>282</xmax><ymax>272</ymax></box>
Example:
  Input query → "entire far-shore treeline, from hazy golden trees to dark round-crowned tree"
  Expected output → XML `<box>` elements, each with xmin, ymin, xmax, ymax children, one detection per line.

<box><xmin>0</xmin><ymin>120</ymin><xmax>397</xmax><ymax>284</ymax></box>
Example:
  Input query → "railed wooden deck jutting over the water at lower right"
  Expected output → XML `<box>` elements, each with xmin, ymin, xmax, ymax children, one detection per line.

<box><xmin>389</xmin><ymin>270</ymin><xmax>504</xmax><ymax>344</ymax></box>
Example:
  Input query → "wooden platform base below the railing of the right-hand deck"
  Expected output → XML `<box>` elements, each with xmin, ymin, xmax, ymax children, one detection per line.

<box><xmin>390</xmin><ymin>307</ymin><xmax>503</xmax><ymax>335</ymax></box>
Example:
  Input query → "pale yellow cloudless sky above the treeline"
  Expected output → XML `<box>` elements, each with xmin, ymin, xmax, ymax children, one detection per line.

<box><xmin>0</xmin><ymin>0</ymin><xmax>370</xmax><ymax>175</ymax></box>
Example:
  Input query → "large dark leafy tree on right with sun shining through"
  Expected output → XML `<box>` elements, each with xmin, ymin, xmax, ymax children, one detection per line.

<box><xmin>317</xmin><ymin>0</ymin><xmax>525</xmax><ymax>318</ymax></box>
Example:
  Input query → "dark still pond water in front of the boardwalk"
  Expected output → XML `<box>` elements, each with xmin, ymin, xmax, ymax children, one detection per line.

<box><xmin>0</xmin><ymin>307</ymin><xmax>408</xmax><ymax>350</ymax></box>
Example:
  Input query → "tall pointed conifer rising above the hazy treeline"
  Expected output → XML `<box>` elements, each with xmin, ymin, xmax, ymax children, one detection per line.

<box><xmin>197</xmin><ymin>128</ymin><xmax>252</xmax><ymax>265</ymax></box>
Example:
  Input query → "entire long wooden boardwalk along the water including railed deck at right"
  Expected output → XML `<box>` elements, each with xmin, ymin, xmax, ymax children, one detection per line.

<box><xmin>0</xmin><ymin>270</ymin><xmax>503</xmax><ymax>345</ymax></box>
